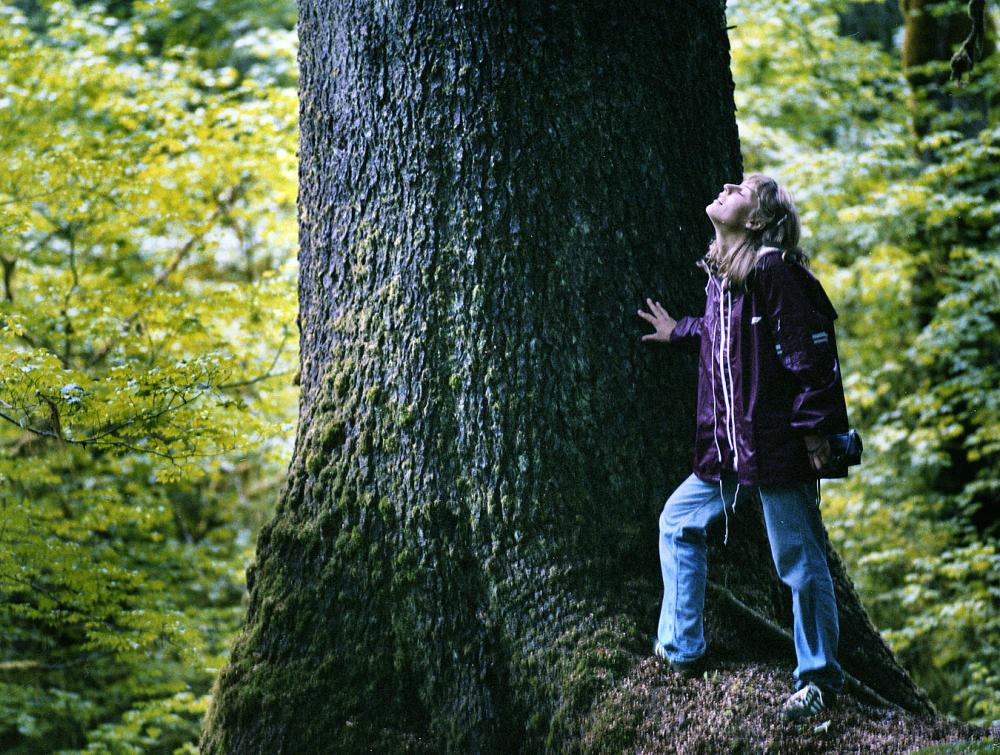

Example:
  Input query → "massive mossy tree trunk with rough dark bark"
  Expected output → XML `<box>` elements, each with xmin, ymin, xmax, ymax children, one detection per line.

<box><xmin>202</xmin><ymin>0</ymin><xmax>984</xmax><ymax>753</ymax></box>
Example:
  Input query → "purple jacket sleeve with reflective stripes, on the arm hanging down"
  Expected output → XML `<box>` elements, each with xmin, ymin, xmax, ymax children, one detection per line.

<box><xmin>759</xmin><ymin>262</ymin><xmax>847</xmax><ymax>434</ymax></box>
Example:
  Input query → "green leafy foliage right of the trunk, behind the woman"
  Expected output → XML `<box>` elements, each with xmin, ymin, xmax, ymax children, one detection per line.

<box><xmin>729</xmin><ymin>0</ymin><xmax>1000</xmax><ymax>724</ymax></box>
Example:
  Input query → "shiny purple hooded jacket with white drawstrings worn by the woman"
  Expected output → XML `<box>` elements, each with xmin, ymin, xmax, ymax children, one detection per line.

<box><xmin>670</xmin><ymin>247</ymin><xmax>848</xmax><ymax>485</ymax></box>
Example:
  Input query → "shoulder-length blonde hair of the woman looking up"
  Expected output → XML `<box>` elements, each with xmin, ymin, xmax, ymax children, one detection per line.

<box><xmin>698</xmin><ymin>173</ymin><xmax>809</xmax><ymax>288</ymax></box>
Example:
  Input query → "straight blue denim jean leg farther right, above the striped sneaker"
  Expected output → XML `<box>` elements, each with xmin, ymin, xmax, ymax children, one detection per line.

<box><xmin>760</xmin><ymin>482</ymin><xmax>844</xmax><ymax>692</ymax></box>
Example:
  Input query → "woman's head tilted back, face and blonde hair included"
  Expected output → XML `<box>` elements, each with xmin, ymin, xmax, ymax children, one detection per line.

<box><xmin>701</xmin><ymin>173</ymin><xmax>808</xmax><ymax>287</ymax></box>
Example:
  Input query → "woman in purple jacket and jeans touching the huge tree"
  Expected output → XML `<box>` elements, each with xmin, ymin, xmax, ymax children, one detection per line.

<box><xmin>638</xmin><ymin>174</ymin><xmax>848</xmax><ymax>719</ymax></box>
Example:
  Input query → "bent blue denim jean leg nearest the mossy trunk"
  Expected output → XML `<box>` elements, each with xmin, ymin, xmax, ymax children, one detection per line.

<box><xmin>656</xmin><ymin>474</ymin><xmax>733</xmax><ymax>662</ymax></box>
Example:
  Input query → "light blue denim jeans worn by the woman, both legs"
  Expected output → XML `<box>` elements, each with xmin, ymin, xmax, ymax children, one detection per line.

<box><xmin>656</xmin><ymin>472</ymin><xmax>844</xmax><ymax>692</ymax></box>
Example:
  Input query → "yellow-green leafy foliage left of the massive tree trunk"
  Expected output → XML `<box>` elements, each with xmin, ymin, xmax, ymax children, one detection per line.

<box><xmin>0</xmin><ymin>2</ymin><xmax>297</xmax><ymax>752</ymax></box>
